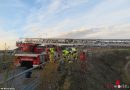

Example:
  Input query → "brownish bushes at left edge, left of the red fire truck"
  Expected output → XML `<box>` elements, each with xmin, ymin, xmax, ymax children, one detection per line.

<box><xmin>0</xmin><ymin>44</ymin><xmax>15</xmax><ymax>87</ymax></box>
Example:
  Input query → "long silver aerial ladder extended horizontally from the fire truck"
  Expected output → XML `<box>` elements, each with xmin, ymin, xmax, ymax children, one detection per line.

<box><xmin>17</xmin><ymin>38</ymin><xmax>130</xmax><ymax>47</ymax></box>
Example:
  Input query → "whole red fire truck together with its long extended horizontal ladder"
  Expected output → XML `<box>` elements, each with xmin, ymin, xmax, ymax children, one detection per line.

<box><xmin>15</xmin><ymin>38</ymin><xmax>130</xmax><ymax>66</ymax></box>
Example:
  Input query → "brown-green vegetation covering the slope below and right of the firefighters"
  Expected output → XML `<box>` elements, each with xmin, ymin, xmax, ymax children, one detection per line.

<box><xmin>38</xmin><ymin>49</ymin><xmax>130</xmax><ymax>90</ymax></box>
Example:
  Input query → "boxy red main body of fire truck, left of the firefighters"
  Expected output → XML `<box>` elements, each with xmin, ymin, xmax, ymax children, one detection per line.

<box><xmin>15</xmin><ymin>42</ymin><xmax>48</xmax><ymax>67</ymax></box>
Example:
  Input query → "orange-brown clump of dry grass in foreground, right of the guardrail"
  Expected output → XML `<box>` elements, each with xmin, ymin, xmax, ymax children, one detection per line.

<box><xmin>38</xmin><ymin>63</ymin><xmax>58</xmax><ymax>90</ymax></box>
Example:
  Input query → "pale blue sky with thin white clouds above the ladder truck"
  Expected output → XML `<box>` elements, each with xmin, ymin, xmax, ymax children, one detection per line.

<box><xmin>0</xmin><ymin>0</ymin><xmax>130</xmax><ymax>49</ymax></box>
